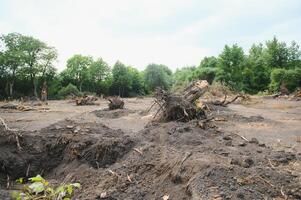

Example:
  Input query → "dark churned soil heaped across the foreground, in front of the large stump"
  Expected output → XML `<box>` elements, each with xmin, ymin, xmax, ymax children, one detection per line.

<box><xmin>0</xmin><ymin>107</ymin><xmax>301</xmax><ymax>200</ymax></box>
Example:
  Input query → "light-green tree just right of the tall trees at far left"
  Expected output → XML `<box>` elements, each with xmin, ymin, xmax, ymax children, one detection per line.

<box><xmin>63</xmin><ymin>54</ymin><xmax>93</xmax><ymax>92</ymax></box>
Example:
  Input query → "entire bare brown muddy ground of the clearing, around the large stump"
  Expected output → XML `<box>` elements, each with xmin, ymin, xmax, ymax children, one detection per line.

<box><xmin>0</xmin><ymin>98</ymin><xmax>301</xmax><ymax>200</ymax></box>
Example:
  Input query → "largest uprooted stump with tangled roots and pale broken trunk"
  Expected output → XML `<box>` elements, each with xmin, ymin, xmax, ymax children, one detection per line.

<box><xmin>154</xmin><ymin>80</ymin><xmax>209</xmax><ymax>122</ymax></box>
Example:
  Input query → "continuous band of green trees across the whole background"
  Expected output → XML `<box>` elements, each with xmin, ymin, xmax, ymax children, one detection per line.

<box><xmin>0</xmin><ymin>33</ymin><xmax>301</xmax><ymax>99</ymax></box>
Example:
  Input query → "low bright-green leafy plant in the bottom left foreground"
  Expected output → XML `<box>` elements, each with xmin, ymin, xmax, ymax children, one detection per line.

<box><xmin>13</xmin><ymin>175</ymin><xmax>80</xmax><ymax>200</ymax></box>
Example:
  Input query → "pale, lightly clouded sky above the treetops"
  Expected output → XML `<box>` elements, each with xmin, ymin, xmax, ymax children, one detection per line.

<box><xmin>0</xmin><ymin>0</ymin><xmax>301</xmax><ymax>71</ymax></box>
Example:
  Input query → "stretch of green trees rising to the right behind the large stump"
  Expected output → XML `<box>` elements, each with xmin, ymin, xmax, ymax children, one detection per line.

<box><xmin>174</xmin><ymin>37</ymin><xmax>301</xmax><ymax>94</ymax></box>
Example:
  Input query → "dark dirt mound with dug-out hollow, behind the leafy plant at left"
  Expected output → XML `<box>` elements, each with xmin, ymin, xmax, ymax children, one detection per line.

<box><xmin>0</xmin><ymin>121</ymin><xmax>134</xmax><ymax>188</ymax></box>
